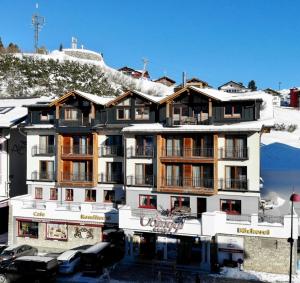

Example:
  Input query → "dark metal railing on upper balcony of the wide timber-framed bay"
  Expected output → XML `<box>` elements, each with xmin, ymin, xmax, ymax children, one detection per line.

<box><xmin>162</xmin><ymin>147</ymin><xmax>214</xmax><ymax>158</ymax></box>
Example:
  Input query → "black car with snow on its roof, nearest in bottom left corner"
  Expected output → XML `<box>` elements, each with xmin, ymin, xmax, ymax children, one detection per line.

<box><xmin>5</xmin><ymin>256</ymin><xmax>58</xmax><ymax>283</ymax></box>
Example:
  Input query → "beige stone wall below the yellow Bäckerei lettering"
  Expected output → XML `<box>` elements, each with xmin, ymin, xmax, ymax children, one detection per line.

<box><xmin>244</xmin><ymin>236</ymin><xmax>297</xmax><ymax>274</ymax></box>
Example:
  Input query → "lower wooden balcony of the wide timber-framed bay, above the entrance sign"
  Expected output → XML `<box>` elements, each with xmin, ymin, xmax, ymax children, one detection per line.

<box><xmin>157</xmin><ymin>177</ymin><xmax>217</xmax><ymax>195</ymax></box>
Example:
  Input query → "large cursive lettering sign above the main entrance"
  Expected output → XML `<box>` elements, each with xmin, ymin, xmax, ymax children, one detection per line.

<box><xmin>140</xmin><ymin>217</ymin><xmax>184</xmax><ymax>234</ymax></box>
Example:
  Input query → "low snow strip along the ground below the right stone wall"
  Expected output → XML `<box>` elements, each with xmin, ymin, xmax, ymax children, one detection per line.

<box><xmin>216</xmin><ymin>267</ymin><xmax>300</xmax><ymax>283</ymax></box>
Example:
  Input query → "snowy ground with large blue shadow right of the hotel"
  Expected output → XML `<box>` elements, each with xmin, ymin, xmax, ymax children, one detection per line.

<box><xmin>261</xmin><ymin>107</ymin><xmax>300</xmax><ymax>214</ymax></box>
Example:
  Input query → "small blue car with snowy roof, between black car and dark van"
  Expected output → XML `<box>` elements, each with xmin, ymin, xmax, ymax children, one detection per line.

<box><xmin>57</xmin><ymin>250</ymin><xmax>81</xmax><ymax>274</ymax></box>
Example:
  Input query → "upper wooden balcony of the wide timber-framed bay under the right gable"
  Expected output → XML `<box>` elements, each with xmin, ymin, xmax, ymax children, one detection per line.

<box><xmin>160</xmin><ymin>147</ymin><xmax>214</xmax><ymax>163</ymax></box>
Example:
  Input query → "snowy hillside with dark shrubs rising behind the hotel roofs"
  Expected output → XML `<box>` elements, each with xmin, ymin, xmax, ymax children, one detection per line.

<box><xmin>0</xmin><ymin>49</ymin><xmax>173</xmax><ymax>100</ymax></box>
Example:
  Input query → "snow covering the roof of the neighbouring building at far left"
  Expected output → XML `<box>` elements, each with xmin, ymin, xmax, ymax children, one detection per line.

<box><xmin>0</xmin><ymin>97</ymin><xmax>50</xmax><ymax>128</ymax></box>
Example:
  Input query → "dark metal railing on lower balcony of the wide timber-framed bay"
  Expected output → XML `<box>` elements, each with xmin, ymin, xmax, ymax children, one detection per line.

<box><xmin>162</xmin><ymin>177</ymin><xmax>214</xmax><ymax>189</ymax></box>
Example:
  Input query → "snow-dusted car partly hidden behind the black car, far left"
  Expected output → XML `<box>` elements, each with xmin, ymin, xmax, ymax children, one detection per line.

<box><xmin>0</xmin><ymin>245</ymin><xmax>38</xmax><ymax>267</ymax></box>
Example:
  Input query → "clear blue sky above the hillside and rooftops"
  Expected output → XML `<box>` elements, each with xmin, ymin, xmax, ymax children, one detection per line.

<box><xmin>0</xmin><ymin>0</ymin><xmax>300</xmax><ymax>89</ymax></box>
